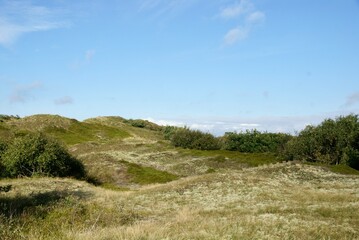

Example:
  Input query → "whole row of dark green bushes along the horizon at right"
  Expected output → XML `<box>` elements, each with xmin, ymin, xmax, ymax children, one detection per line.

<box><xmin>162</xmin><ymin>114</ymin><xmax>359</xmax><ymax>170</ymax></box>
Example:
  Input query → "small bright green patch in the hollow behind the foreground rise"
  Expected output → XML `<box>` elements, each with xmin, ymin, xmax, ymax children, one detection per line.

<box><xmin>121</xmin><ymin>161</ymin><xmax>178</xmax><ymax>185</ymax></box>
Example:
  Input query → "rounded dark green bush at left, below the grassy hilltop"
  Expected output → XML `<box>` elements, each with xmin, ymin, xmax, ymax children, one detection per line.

<box><xmin>1</xmin><ymin>133</ymin><xmax>85</xmax><ymax>178</ymax></box>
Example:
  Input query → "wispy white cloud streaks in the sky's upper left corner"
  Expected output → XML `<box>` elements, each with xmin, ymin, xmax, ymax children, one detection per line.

<box><xmin>0</xmin><ymin>1</ymin><xmax>67</xmax><ymax>46</ymax></box>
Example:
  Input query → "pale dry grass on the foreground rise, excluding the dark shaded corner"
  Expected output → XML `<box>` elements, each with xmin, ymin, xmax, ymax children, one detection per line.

<box><xmin>1</xmin><ymin>163</ymin><xmax>359</xmax><ymax>240</ymax></box>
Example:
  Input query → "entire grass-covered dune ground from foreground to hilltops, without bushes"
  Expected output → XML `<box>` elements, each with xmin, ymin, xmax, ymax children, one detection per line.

<box><xmin>0</xmin><ymin>115</ymin><xmax>359</xmax><ymax>240</ymax></box>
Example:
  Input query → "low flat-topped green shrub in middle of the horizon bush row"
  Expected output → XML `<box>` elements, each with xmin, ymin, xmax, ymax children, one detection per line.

<box><xmin>222</xmin><ymin>130</ymin><xmax>292</xmax><ymax>153</ymax></box>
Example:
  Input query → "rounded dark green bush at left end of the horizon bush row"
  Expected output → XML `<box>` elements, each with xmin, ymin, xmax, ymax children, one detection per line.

<box><xmin>171</xmin><ymin>127</ymin><xmax>220</xmax><ymax>150</ymax></box>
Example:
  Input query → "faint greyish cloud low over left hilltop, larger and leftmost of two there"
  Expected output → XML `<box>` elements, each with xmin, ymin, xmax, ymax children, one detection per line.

<box><xmin>9</xmin><ymin>81</ymin><xmax>42</xmax><ymax>103</ymax></box>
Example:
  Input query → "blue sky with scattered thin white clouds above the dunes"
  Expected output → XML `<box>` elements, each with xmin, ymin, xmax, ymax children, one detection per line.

<box><xmin>0</xmin><ymin>0</ymin><xmax>359</xmax><ymax>135</ymax></box>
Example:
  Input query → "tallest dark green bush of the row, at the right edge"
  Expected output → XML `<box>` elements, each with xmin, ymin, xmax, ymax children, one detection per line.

<box><xmin>285</xmin><ymin>115</ymin><xmax>359</xmax><ymax>169</ymax></box>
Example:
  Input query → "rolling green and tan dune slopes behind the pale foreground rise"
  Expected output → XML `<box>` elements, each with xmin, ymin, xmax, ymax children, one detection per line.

<box><xmin>0</xmin><ymin>115</ymin><xmax>278</xmax><ymax>188</ymax></box>
